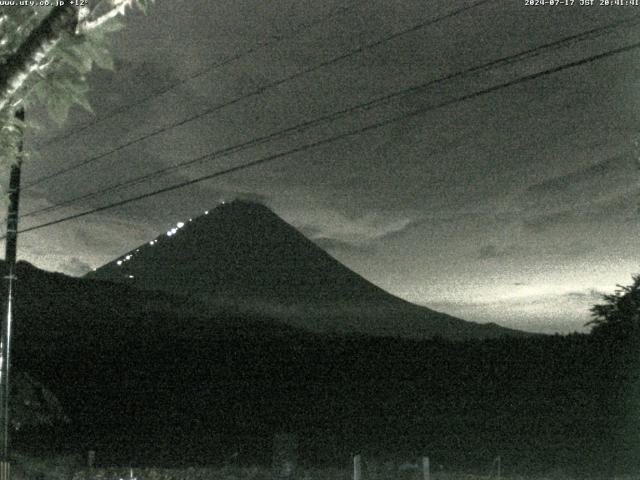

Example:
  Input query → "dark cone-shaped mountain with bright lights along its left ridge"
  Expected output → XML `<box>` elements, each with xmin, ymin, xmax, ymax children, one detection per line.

<box><xmin>86</xmin><ymin>200</ymin><xmax>522</xmax><ymax>340</ymax></box>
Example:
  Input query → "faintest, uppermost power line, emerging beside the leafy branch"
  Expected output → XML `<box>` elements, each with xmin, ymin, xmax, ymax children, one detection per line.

<box><xmin>37</xmin><ymin>1</ymin><xmax>354</xmax><ymax>147</ymax></box>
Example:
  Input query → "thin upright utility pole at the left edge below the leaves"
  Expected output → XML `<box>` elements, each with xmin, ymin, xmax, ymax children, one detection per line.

<box><xmin>0</xmin><ymin>108</ymin><xmax>24</xmax><ymax>480</ymax></box>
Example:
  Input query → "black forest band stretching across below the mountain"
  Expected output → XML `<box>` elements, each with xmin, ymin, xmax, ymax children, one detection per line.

<box><xmin>5</xmin><ymin>262</ymin><xmax>640</xmax><ymax>476</ymax></box>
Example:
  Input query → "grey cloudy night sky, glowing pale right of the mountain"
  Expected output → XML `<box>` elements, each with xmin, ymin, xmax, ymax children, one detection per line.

<box><xmin>6</xmin><ymin>0</ymin><xmax>640</xmax><ymax>332</ymax></box>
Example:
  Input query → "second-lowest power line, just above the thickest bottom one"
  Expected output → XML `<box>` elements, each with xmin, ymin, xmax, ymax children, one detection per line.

<box><xmin>22</xmin><ymin>15</ymin><xmax>640</xmax><ymax>218</ymax></box>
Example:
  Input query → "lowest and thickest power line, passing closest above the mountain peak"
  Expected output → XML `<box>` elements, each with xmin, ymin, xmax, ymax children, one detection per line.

<box><xmin>12</xmin><ymin>38</ymin><xmax>640</xmax><ymax>239</ymax></box>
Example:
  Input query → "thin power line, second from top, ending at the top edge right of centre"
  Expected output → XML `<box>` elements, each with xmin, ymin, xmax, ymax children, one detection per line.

<box><xmin>23</xmin><ymin>0</ymin><xmax>494</xmax><ymax>190</ymax></box>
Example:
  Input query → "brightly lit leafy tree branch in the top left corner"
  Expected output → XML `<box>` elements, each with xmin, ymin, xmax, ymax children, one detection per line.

<box><xmin>0</xmin><ymin>0</ymin><xmax>153</xmax><ymax>170</ymax></box>
